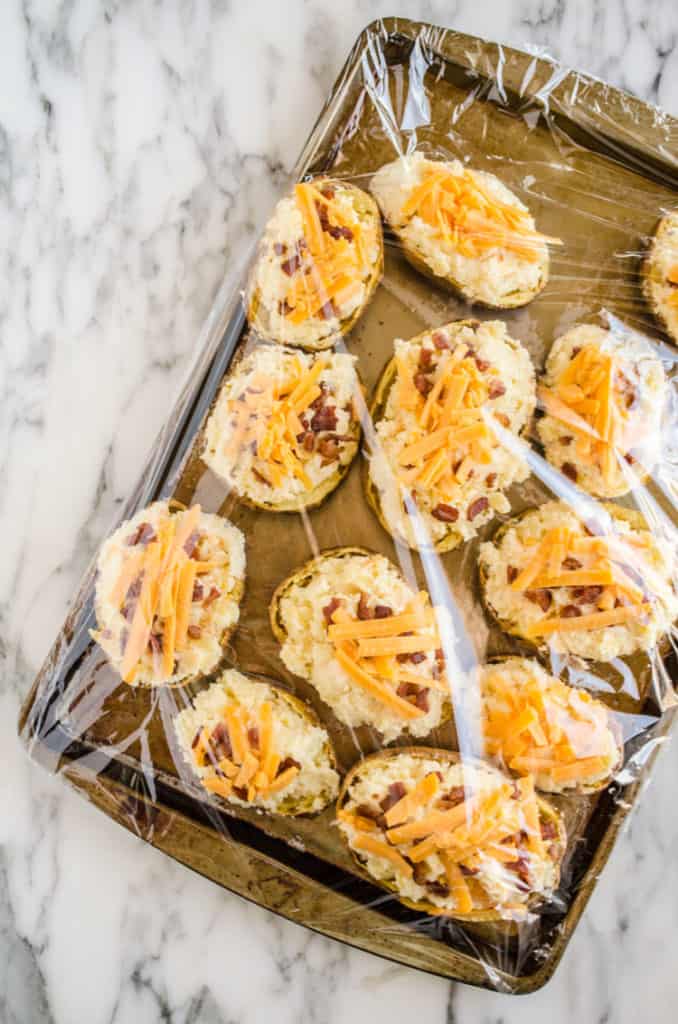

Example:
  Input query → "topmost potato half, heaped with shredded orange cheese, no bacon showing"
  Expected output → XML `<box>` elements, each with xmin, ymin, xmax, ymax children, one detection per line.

<box><xmin>370</xmin><ymin>153</ymin><xmax>560</xmax><ymax>309</ymax></box>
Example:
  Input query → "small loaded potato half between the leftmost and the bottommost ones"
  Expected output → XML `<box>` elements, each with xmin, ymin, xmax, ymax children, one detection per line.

<box><xmin>174</xmin><ymin>669</ymin><xmax>339</xmax><ymax>815</ymax></box>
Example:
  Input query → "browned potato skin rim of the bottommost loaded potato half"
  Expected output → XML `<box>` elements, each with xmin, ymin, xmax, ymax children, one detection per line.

<box><xmin>337</xmin><ymin>746</ymin><xmax>567</xmax><ymax>924</ymax></box>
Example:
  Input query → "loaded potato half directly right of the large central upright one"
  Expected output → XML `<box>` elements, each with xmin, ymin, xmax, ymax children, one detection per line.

<box><xmin>537</xmin><ymin>321</ymin><xmax>667</xmax><ymax>498</ymax></box>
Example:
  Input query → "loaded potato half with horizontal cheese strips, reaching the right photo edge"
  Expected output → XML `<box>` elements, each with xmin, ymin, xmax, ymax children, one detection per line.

<box><xmin>479</xmin><ymin>502</ymin><xmax>678</xmax><ymax>662</ymax></box>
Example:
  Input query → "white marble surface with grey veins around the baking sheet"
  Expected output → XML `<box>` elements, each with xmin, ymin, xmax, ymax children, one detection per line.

<box><xmin>0</xmin><ymin>0</ymin><xmax>678</xmax><ymax>1024</ymax></box>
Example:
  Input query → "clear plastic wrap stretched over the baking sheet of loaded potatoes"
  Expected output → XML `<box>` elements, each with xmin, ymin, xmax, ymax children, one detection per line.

<box><xmin>20</xmin><ymin>19</ymin><xmax>678</xmax><ymax>992</ymax></box>
